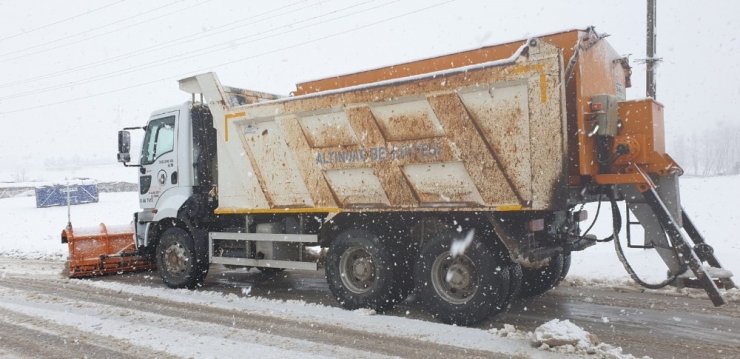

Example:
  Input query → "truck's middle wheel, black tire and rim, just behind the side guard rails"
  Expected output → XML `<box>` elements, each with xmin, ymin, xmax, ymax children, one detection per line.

<box><xmin>326</xmin><ymin>229</ymin><xmax>413</xmax><ymax>311</ymax></box>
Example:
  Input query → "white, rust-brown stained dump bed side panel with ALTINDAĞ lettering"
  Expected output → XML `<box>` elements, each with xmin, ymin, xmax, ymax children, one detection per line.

<box><xmin>215</xmin><ymin>42</ymin><xmax>567</xmax><ymax>213</ymax></box>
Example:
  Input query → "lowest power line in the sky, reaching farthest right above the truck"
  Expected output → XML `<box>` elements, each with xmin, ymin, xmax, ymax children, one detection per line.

<box><xmin>0</xmin><ymin>0</ymin><xmax>457</xmax><ymax>115</ymax></box>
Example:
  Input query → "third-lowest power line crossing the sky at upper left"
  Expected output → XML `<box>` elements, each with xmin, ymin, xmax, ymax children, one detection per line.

<box><xmin>0</xmin><ymin>0</ymin><xmax>314</xmax><ymax>88</ymax></box>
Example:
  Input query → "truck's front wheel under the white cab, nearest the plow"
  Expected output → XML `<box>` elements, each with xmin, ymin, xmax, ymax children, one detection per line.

<box><xmin>157</xmin><ymin>227</ymin><xmax>208</xmax><ymax>289</ymax></box>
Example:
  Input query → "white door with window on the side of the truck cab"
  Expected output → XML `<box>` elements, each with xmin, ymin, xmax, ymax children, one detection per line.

<box><xmin>139</xmin><ymin>111</ymin><xmax>179</xmax><ymax>209</ymax></box>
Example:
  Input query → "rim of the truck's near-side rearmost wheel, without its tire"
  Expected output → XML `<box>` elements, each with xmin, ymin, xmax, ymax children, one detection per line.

<box><xmin>432</xmin><ymin>252</ymin><xmax>479</xmax><ymax>304</ymax></box>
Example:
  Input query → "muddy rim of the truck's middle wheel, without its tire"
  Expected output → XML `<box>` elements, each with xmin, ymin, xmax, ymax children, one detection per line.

<box><xmin>339</xmin><ymin>247</ymin><xmax>376</xmax><ymax>294</ymax></box>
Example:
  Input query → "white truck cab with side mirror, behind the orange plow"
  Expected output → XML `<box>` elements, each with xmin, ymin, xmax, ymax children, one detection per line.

<box><xmin>119</xmin><ymin>102</ymin><xmax>215</xmax><ymax>255</ymax></box>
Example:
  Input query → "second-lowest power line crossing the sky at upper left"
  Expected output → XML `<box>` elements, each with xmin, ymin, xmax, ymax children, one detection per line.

<box><xmin>0</xmin><ymin>0</ymin><xmax>388</xmax><ymax>100</ymax></box>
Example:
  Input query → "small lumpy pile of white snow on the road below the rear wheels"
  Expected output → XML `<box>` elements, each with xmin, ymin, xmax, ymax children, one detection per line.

<box><xmin>488</xmin><ymin>319</ymin><xmax>649</xmax><ymax>359</ymax></box>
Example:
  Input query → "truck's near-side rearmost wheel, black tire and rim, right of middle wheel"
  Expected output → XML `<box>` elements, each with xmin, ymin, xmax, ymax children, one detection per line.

<box><xmin>414</xmin><ymin>233</ymin><xmax>509</xmax><ymax>325</ymax></box>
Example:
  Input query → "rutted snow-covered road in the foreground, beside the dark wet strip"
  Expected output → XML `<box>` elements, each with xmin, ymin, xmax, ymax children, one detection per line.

<box><xmin>0</xmin><ymin>258</ymin><xmax>559</xmax><ymax>358</ymax></box>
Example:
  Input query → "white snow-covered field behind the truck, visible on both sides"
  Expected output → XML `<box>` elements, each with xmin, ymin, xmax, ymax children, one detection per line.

<box><xmin>0</xmin><ymin>176</ymin><xmax>740</xmax><ymax>281</ymax></box>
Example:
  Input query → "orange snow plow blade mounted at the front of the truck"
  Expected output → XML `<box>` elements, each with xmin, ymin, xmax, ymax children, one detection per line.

<box><xmin>62</xmin><ymin>223</ymin><xmax>155</xmax><ymax>278</ymax></box>
